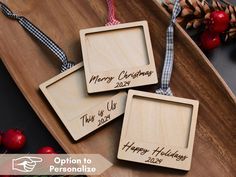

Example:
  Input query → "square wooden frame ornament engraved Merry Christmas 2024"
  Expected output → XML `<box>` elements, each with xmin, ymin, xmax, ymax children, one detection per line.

<box><xmin>80</xmin><ymin>21</ymin><xmax>158</xmax><ymax>93</ymax></box>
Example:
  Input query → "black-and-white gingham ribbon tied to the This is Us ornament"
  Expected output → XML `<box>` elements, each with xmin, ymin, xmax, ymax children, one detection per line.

<box><xmin>0</xmin><ymin>2</ymin><xmax>74</xmax><ymax>72</ymax></box>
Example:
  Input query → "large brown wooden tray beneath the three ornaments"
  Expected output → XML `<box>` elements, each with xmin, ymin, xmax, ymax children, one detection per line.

<box><xmin>0</xmin><ymin>0</ymin><xmax>236</xmax><ymax>177</ymax></box>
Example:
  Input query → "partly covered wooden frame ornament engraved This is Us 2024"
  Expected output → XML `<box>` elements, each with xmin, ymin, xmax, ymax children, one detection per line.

<box><xmin>39</xmin><ymin>63</ymin><xmax>127</xmax><ymax>140</ymax></box>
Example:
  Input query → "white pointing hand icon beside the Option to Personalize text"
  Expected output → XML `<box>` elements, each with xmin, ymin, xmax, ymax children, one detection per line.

<box><xmin>12</xmin><ymin>156</ymin><xmax>43</xmax><ymax>173</ymax></box>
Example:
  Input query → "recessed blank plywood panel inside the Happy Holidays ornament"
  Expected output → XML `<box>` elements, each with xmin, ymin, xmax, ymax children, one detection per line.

<box><xmin>124</xmin><ymin>96</ymin><xmax>193</xmax><ymax>148</ymax></box>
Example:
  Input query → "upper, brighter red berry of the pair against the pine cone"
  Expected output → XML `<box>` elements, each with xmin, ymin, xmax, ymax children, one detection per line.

<box><xmin>208</xmin><ymin>10</ymin><xmax>230</xmax><ymax>33</ymax></box>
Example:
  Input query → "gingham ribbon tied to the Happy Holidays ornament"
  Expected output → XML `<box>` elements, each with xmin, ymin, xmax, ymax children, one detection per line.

<box><xmin>156</xmin><ymin>0</ymin><xmax>181</xmax><ymax>96</ymax></box>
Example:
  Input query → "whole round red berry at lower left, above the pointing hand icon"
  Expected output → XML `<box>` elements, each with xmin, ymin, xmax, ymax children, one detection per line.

<box><xmin>2</xmin><ymin>129</ymin><xmax>26</xmax><ymax>151</ymax></box>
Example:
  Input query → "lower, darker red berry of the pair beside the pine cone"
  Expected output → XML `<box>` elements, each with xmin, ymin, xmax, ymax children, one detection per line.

<box><xmin>201</xmin><ymin>31</ymin><xmax>220</xmax><ymax>50</ymax></box>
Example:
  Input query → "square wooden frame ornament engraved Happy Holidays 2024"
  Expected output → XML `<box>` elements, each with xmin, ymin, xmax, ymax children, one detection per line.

<box><xmin>118</xmin><ymin>90</ymin><xmax>199</xmax><ymax>170</ymax></box>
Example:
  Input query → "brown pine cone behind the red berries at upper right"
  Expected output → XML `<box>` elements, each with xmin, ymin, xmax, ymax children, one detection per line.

<box><xmin>162</xmin><ymin>0</ymin><xmax>236</xmax><ymax>42</ymax></box>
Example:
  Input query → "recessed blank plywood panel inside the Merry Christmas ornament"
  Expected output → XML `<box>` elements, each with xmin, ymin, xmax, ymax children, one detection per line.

<box><xmin>85</xmin><ymin>26</ymin><xmax>149</xmax><ymax>72</ymax></box>
